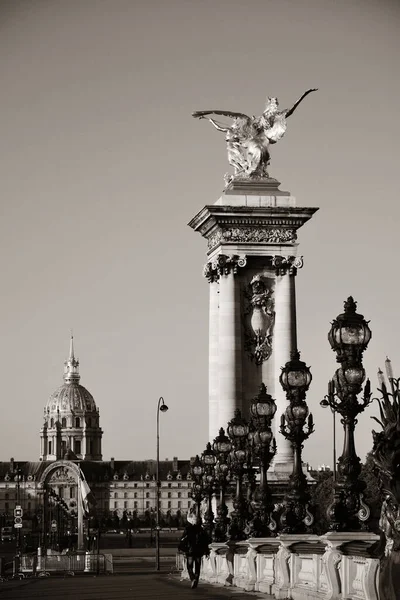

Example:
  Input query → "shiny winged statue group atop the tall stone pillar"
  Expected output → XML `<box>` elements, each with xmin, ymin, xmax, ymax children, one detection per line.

<box><xmin>192</xmin><ymin>88</ymin><xmax>318</xmax><ymax>183</ymax></box>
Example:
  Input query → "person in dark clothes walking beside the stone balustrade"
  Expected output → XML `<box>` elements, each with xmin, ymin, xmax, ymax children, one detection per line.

<box><xmin>178</xmin><ymin>516</ymin><xmax>210</xmax><ymax>588</ymax></box>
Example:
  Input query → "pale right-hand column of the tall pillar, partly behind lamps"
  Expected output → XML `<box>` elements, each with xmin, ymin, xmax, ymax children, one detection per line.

<box><xmin>273</xmin><ymin>256</ymin><xmax>303</xmax><ymax>474</ymax></box>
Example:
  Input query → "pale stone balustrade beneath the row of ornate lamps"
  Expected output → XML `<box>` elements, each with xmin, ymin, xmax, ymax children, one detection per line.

<box><xmin>182</xmin><ymin>532</ymin><xmax>379</xmax><ymax>600</ymax></box>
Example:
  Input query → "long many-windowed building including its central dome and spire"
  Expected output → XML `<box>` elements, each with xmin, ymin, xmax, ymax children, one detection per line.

<box><xmin>0</xmin><ymin>338</ymin><xmax>192</xmax><ymax>529</ymax></box>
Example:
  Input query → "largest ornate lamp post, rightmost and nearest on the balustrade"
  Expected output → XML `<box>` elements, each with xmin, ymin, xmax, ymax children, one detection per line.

<box><xmin>325</xmin><ymin>296</ymin><xmax>371</xmax><ymax>531</ymax></box>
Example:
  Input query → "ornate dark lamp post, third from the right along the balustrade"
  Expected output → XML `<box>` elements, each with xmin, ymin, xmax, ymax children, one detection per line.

<box><xmin>249</xmin><ymin>383</ymin><xmax>276</xmax><ymax>536</ymax></box>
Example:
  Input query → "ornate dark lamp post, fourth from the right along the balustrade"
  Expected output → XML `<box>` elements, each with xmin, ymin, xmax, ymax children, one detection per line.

<box><xmin>227</xmin><ymin>408</ymin><xmax>250</xmax><ymax>540</ymax></box>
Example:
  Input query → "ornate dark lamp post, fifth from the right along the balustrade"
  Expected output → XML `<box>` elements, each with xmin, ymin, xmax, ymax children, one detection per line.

<box><xmin>213</xmin><ymin>427</ymin><xmax>232</xmax><ymax>542</ymax></box>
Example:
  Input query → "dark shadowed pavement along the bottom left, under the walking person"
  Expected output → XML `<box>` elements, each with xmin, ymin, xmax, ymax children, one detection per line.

<box><xmin>0</xmin><ymin>571</ymin><xmax>272</xmax><ymax>600</ymax></box>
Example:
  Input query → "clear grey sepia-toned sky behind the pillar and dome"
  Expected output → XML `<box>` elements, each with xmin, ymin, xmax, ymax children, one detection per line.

<box><xmin>0</xmin><ymin>0</ymin><xmax>400</xmax><ymax>467</ymax></box>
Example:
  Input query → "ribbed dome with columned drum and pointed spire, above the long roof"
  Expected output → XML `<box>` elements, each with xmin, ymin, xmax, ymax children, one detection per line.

<box><xmin>40</xmin><ymin>336</ymin><xmax>103</xmax><ymax>461</ymax></box>
